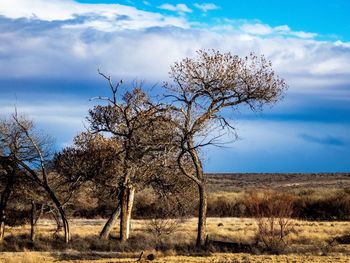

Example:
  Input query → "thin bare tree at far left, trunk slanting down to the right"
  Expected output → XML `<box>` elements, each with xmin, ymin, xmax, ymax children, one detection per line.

<box><xmin>0</xmin><ymin>112</ymin><xmax>70</xmax><ymax>243</ymax></box>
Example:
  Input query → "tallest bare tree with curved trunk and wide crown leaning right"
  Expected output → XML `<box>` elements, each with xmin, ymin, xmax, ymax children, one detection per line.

<box><xmin>165</xmin><ymin>50</ymin><xmax>286</xmax><ymax>247</ymax></box>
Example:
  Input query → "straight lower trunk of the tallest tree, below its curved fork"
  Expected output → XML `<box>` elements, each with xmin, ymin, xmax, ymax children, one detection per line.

<box><xmin>196</xmin><ymin>182</ymin><xmax>207</xmax><ymax>248</ymax></box>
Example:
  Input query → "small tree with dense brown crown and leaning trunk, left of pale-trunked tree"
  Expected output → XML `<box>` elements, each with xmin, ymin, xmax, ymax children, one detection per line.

<box><xmin>54</xmin><ymin>132</ymin><xmax>122</xmax><ymax>239</ymax></box>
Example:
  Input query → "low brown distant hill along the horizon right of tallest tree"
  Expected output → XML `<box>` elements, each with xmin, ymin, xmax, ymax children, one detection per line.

<box><xmin>206</xmin><ymin>173</ymin><xmax>350</xmax><ymax>192</ymax></box>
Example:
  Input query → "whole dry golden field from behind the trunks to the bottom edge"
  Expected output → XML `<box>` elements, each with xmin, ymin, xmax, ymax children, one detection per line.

<box><xmin>0</xmin><ymin>218</ymin><xmax>350</xmax><ymax>263</ymax></box>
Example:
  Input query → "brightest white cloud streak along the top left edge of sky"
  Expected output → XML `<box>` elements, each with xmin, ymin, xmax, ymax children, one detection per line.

<box><xmin>0</xmin><ymin>0</ymin><xmax>188</xmax><ymax>31</ymax></box>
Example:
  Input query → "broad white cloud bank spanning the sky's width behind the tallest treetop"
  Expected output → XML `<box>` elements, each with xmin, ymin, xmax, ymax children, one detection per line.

<box><xmin>0</xmin><ymin>0</ymin><xmax>350</xmax><ymax>94</ymax></box>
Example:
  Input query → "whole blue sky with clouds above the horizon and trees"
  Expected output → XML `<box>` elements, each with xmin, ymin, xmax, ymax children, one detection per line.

<box><xmin>0</xmin><ymin>0</ymin><xmax>350</xmax><ymax>172</ymax></box>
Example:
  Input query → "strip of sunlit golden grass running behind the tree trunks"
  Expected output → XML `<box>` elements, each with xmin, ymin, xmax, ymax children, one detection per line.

<box><xmin>2</xmin><ymin>218</ymin><xmax>350</xmax><ymax>242</ymax></box>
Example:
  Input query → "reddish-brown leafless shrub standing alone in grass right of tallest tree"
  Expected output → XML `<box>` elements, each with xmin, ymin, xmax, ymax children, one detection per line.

<box><xmin>247</xmin><ymin>191</ymin><xmax>293</xmax><ymax>254</ymax></box>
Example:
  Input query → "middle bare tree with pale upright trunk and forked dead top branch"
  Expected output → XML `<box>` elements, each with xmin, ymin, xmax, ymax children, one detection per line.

<box><xmin>88</xmin><ymin>72</ymin><xmax>173</xmax><ymax>241</ymax></box>
